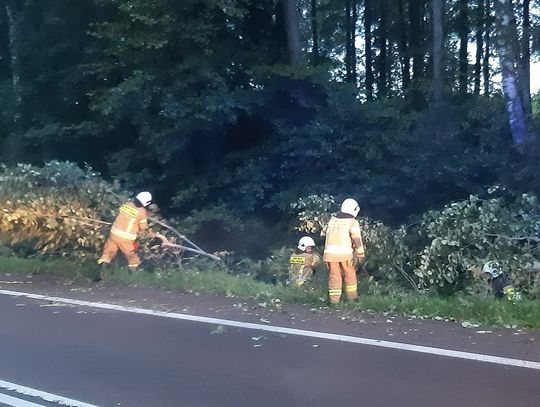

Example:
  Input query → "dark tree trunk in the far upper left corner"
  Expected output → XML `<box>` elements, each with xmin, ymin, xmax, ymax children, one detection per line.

<box><xmin>6</xmin><ymin>3</ymin><xmax>23</xmax><ymax>122</ymax></box>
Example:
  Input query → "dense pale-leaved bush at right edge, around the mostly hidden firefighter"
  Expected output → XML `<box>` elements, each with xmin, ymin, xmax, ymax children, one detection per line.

<box><xmin>415</xmin><ymin>194</ymin><xmax>540</xmax><ymax>295</ymax></box>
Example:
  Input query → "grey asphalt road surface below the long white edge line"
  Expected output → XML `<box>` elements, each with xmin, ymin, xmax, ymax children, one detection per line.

<box><xmin>0</xmin><ymin>295</ymin><xmax>540</xmax><ymax>407</ymax></box>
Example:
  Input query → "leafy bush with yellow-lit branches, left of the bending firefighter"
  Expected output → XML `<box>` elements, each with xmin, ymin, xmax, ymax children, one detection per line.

<box><xmin>0</xmin><ymin>161</ymin><xmax>177</xmax><ymax>258</ymax></box>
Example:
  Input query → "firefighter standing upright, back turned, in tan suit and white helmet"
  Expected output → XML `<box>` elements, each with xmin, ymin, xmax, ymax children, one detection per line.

<box><xmin>323</xmin><ymin>198</ymin><xmax>365</xmax><ymax>304</ymax></box>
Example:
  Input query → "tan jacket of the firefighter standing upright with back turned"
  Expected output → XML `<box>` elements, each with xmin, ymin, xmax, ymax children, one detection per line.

<box><xmin>323</xmin><ymin>215</ymin><xmax>364</xmax><ymax>262</ymax></box>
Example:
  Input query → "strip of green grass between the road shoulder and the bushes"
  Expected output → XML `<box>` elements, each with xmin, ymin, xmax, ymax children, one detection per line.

<box><xmin>0</xmin><ymin>257</ymin><xmax>540</xmax><ymax>329</ymax></box>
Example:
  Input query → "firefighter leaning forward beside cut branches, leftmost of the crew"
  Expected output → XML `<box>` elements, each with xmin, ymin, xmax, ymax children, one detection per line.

<box><xmin>98</xmin><ymin>192</ymin><xmax>152</xmax><ymax>270</ymax></box>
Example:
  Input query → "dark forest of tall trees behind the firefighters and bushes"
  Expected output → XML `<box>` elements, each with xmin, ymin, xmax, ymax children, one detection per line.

<box><xmin>0</xmin><ymin>0</ymin><xmax>540</xmax><ymax>255</ymax></box>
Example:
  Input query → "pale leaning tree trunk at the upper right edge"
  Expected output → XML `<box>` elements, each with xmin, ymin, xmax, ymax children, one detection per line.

<box><xmin>494</xmin><ymin>0</ymin><xmax>529</xmax><ymax>147</ymax></box>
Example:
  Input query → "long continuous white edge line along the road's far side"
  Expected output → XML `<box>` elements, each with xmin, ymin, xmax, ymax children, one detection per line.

<box><xmin>0</xmin><ymin>290</ymin><xmax>540</xmax><ymax>370</ymax></box>
